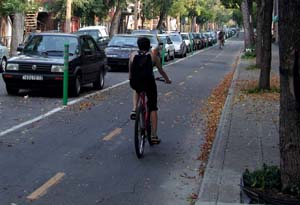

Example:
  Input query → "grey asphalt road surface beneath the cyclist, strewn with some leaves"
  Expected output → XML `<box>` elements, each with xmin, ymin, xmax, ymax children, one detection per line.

<box><xmin>0</xmin><ymin>39</ymin><xmax>243</xmax><ymax>205</ymax></box>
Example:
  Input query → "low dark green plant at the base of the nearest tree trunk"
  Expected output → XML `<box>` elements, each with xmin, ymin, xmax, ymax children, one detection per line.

<box><xmin>243</xmin><ymin>164</ymin><xmax>282</xmax><ymax>190</ymax></box>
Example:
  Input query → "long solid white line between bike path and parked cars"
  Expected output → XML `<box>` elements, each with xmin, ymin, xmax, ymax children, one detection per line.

<box><xmin>0</xmin><ymin>47</ymin><xmax>216</xmax><ymax>137</ymax></box>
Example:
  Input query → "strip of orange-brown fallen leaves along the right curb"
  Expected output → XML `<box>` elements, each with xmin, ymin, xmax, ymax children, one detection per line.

<box><xmin>198</xmin><ymin>72</ymin><xmax>234</xmax><ymax>176</ymax></box>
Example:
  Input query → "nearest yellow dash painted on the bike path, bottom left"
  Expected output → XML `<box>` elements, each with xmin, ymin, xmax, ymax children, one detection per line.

<box><xmin>26</xmin><ymin>172</ymin><xmax>65</xmax><ymax>200</ymax></box>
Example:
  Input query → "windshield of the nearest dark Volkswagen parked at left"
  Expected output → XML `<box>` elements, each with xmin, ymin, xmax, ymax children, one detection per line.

<box><xmin>23</xmin><ymin>35</ymin><xmax>78</xmax><ymax>56</ymax></box>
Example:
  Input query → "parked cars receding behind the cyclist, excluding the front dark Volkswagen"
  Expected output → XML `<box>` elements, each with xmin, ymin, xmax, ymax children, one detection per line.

<box><xmin>105</xmin><ymin>30</ymin><xmax>217</xmax><ymax>69</ymax></box>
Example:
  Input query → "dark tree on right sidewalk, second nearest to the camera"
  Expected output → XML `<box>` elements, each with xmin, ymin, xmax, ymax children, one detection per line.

<box><xmin>256</xmin><ymin>0</ymin><xmax>273</xmax><ymax>89</ymax></box>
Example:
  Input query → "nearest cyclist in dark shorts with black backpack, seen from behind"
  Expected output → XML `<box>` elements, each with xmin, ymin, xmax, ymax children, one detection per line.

<box><xmin>129</xmin><ymin>37</ymin><xmax>171</xmax><ymax>144</ymax></box>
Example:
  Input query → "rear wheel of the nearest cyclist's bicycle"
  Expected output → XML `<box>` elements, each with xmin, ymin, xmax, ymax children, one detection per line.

<box><xmin>134</xmin><ymin>106</ymin><xmax>146</xmax><ymax>158</ymax></box>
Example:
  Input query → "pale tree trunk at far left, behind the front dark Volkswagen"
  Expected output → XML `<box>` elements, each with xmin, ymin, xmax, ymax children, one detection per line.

<box><xmin>10</xmin><ymin>13</ymin><xmax>24</xmax><ymax>56</ymax></box>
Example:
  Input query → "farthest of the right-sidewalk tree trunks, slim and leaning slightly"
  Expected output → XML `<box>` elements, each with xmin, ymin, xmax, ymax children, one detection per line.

<box><xmin>241</xmin><ymin>0</ymin><xmax>254</xmax><ymax>49</ymax></box>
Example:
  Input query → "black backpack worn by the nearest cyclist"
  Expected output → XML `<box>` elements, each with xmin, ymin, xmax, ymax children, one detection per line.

<box><xmin>129</xmin><ymin>52</ymin><xmax>154</xmax><ymax>92</ymax></box>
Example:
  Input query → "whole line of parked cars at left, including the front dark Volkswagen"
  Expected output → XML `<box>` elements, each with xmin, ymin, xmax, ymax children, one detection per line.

<box><xmin>0</xmin><ymin>26</ymin><xmax>220</xmax><ymax>96</ymax></box>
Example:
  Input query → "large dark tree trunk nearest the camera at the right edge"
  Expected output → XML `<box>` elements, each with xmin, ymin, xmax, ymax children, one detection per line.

<box><xmin>279</xmin><ymin>0</ymin><xmax>300</xmax><ymax>187</ymax></box>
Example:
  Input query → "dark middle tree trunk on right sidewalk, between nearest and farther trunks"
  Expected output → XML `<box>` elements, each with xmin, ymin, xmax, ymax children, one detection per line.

<box><xmin>256</xmin><ymin>0</ymin><xmax>273</xmax><ymax>90</ymax></box>
